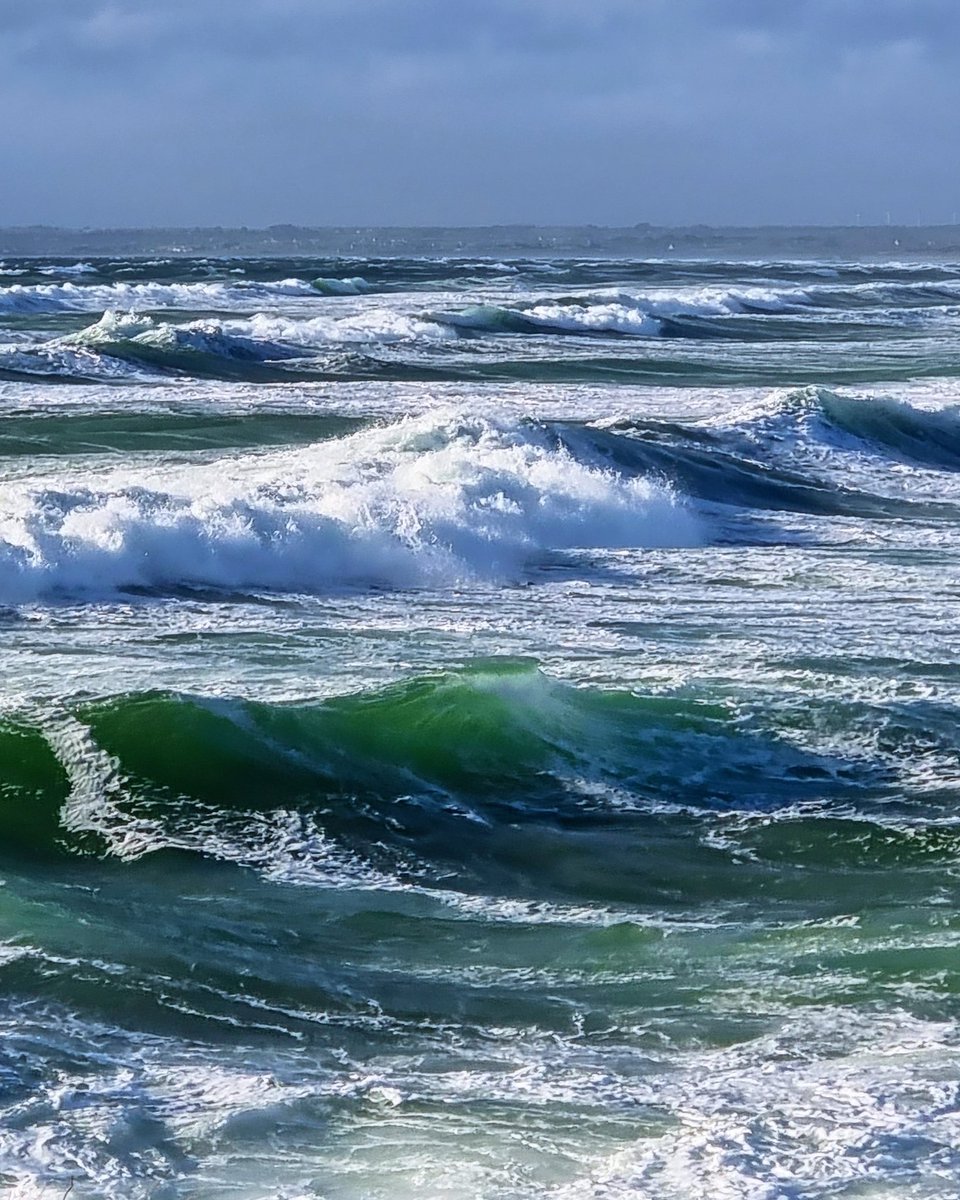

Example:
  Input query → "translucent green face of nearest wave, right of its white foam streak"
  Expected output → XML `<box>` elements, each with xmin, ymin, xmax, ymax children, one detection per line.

<box><xmin>78</xmin><ymin>659</ymin><xmax>849</xmax><ymax>812</ymax></box>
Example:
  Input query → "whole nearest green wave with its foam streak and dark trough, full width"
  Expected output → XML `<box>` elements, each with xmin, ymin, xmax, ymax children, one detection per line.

<box><xmin>0</xmin><ymin>659</ymin><xmax>960</xmax><ymax>904</ymax></box>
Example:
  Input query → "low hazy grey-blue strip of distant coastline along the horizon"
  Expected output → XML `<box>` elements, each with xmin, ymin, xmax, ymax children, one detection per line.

<box><xmin>0</xmin><ymin>224</ymin><xmax>960</xmax><ymax>259</ymax></box>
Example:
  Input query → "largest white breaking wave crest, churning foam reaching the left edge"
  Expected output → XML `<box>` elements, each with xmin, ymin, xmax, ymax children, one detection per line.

<box><xmin>0</xmin><ymin>414</ymin><xmax>701</xmax><ymax>604</ymax></box>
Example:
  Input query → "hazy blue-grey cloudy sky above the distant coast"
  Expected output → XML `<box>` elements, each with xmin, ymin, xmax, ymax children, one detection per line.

<box><xmin>0</xmin><ymin>0</ymin><xmax>960</xmax><ymax>227</ymax></box>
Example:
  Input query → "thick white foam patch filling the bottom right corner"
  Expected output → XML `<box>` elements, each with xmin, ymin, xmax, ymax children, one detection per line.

<box><xmin>546</xmin><ymin>1009</ymin><xmax>960</xmax><ymax>1200</ymax></box>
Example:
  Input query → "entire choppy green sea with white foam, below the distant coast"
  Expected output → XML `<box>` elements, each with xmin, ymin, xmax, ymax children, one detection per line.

<box><xmin>0</xmin><ymin>259</ymin><xmax>960</xmax><ymax>1200</ymax></box>
